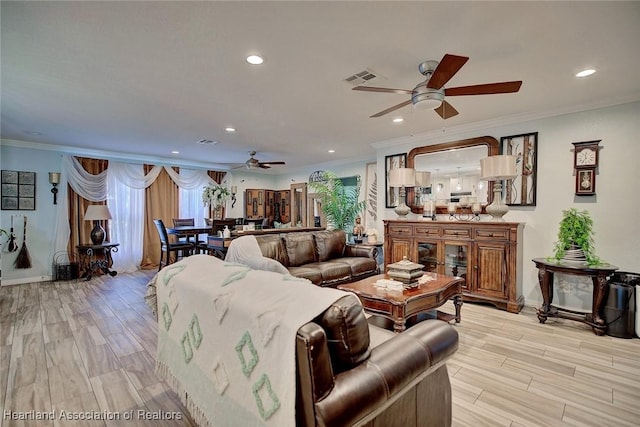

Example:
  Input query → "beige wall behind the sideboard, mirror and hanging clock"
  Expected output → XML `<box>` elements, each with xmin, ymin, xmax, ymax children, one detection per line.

<box><xmin>376</xmin><ymin>102</ymin><xmax>640</xmax><ymax>309</ymax></box>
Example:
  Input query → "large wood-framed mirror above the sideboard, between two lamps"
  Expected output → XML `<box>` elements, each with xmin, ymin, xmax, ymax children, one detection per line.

<box><xmin>407</xmin><ymin>136</ymin><xmax>499</xmax><ymax>213</ymax></box>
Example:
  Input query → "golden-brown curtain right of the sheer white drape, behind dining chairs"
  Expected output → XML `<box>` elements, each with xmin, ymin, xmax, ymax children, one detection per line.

<box><xmin>141</xmin><ymin>165</ymin><xmax>179</xmax><ymax>268</ymax></box>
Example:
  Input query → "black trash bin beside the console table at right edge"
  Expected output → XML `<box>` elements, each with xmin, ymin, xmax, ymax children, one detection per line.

<box><xmin>603</xmin><ymin>272</ymin><xmax>640</xmax><ymax>338</ymax></box>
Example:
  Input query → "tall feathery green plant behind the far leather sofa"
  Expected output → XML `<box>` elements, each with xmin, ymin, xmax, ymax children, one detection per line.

<box><xmin>309</xmin><ymin>171</ymin><xmax>366</xmax><ymax>233</ymax></box>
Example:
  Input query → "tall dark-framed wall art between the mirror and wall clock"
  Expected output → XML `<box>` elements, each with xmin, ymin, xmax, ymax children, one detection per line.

<box><xmin>500</xmin><ymin>132</ymin><xmax>538</xmax><ymax>206</ymax></box>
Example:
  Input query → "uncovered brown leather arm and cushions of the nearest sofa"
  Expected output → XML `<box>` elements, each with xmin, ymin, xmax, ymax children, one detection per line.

<box><xmin>296</xmin><ymin>295</ymin><xmax>458</xmax><ymax>427</ymax></box>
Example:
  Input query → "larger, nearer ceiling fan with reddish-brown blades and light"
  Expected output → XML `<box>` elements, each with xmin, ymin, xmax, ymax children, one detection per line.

<box><xmin>353</xmin><ymin>53</ymin><xmax>522</xmax><ymax>119</ymax></box>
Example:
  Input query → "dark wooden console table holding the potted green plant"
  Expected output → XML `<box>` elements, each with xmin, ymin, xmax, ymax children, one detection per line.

<box><xmin>532</xmin><ymin>258</ymin><xmax>618</xmax><ymax>335</ymax></box>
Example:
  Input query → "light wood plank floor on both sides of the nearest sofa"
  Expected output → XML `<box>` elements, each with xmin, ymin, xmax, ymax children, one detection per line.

<box><xmin>0</xmin><ymin>271</ymin><xmax>640</xmax><ymax>427</ymax></box>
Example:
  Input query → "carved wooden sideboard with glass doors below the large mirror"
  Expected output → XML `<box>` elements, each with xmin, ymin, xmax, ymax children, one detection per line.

<box><xmin>384</xmin><ymin>220</ymin><xmax>524</xmax><ymax>313</ymax></box>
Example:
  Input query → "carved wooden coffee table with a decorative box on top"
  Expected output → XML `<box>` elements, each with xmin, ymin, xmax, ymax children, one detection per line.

<box><xmin>338</xmin><ymin>273</ymin><xmax>464</xmax><ymax>332</ymax></box>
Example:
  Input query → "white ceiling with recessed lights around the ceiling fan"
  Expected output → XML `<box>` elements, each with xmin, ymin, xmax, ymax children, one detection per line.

<box><xmin>1</xmin><ymin>1</ymin><xmax>640</xmax><ymax>173</ymax></box>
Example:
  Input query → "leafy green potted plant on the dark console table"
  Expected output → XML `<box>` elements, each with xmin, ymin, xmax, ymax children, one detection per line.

<box><xmin>552</xmin><ymin>208</ymin><xmax>601</xmax><ymax>265</ymax></box>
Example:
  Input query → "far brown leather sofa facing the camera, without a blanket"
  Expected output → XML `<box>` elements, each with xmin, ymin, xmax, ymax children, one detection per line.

<box><xmin>255</xmin><ymin>230</ymin><xmax>379</xmax><ymax>287</ymax></box>
